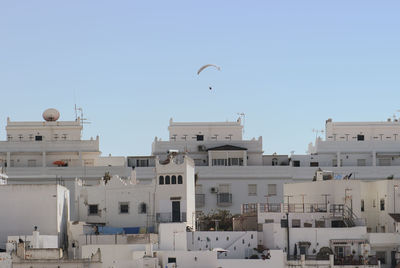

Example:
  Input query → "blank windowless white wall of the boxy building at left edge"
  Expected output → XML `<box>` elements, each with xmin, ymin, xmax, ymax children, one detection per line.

<box><xmin>0</xmin><ymin>185</ymin><xmax>69</xmax><ymax>248</ymax></box>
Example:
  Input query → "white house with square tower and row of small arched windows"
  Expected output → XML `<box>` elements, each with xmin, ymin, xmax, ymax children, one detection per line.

<box><xmin>75</xmin><ymin>155</ymin><xmax>195</xmax><ymax>232</ymax></box>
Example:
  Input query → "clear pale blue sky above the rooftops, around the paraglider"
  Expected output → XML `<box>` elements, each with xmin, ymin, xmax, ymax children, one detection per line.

<box><xmin>0</xmin><ymin>0</ymin><xmax>400</xmax><ymax>155</ymax></box>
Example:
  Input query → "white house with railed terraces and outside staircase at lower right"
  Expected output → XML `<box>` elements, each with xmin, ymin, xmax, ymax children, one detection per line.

<box><xmin>243</xmin><ymin>176</ymin><xmax>400</xmax><ymax>267</ymax></box>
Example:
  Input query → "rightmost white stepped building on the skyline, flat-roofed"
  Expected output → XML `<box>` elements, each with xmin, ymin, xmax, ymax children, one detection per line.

<box><xmin>292</xmin><ymin>119</ymin><xmax>400</xmax><ymax>169</ymax></box>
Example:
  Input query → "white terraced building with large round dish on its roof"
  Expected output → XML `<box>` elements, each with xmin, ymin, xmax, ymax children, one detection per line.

<box><xmin>0</xmin><ymin>109</ymin><xmax>131</xmax><ymax>219</ymax></box>
